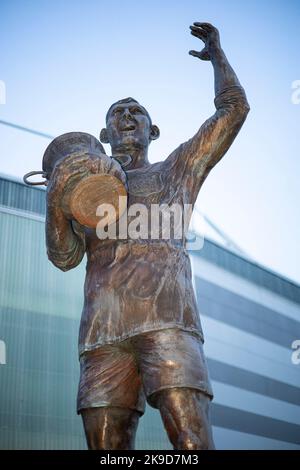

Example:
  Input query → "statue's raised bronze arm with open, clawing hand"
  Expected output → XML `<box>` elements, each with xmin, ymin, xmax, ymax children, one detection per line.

<box><xmin>165</xmin><ymin>23</ymin><xmax>250</xmax><ymax>199</ymax></box>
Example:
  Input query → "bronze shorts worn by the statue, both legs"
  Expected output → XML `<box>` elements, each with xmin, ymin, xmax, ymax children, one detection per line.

<box><xmin>77</xmin><ymin>329</ymin><xmax>213</xmax><ymax>413</ymax></box>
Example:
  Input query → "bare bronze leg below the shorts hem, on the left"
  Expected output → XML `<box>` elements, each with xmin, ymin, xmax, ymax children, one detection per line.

<box><xmin>81</xmin><ymin>407</ymin><xmax>140</xmax><ymax>450</ymax></box>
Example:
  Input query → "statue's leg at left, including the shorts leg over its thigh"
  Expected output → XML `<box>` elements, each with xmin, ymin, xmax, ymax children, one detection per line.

<box><xmin>77</xmin><ymin>341</ymin><xmax>145</xmax><ymax>450</ymax></box>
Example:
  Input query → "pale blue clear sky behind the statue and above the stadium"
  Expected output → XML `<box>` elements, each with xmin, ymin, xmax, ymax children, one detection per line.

<box><xmin>0</xmin><ymin>0</ymin><xmax>300</xmax><ymax>283</ymax></box>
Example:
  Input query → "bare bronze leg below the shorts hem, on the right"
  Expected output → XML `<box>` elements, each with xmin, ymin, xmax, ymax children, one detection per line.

<box><xmin>155</xmin><ymin>388</ymin><xmax>214</xmax><ymax>450</ymax></box>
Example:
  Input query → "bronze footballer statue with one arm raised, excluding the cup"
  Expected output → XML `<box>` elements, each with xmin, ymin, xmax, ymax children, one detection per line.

<box><xmin>42</xmin><ymin>23</ymin><xmax>249</xmax><ymax>449</ymax></box>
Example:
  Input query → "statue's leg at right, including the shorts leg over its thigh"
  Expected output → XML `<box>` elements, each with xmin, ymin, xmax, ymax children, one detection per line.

<box><xmin>134</xmin><ymin>328</ymin><xmax>214</xmax><ymax>449</ymax></box>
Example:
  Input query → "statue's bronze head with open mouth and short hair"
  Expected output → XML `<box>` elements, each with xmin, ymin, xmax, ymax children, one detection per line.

<box><xmin>100</xmin><ymin>98</ymin><xmax>159</xmax><ymax>152</ymax></box>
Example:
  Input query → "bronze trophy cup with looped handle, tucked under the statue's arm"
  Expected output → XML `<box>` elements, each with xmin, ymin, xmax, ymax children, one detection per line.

<box><xmin>23</xmin><ymin>132</ymin><xmax>131</xmax><ymax>228</ymax></box>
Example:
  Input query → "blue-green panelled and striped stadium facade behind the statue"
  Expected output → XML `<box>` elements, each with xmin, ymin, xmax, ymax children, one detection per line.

<box><xmin>0</xmin><ymin>178</ymin><xmax>300</xmax><ymax>449</ymax></box>
